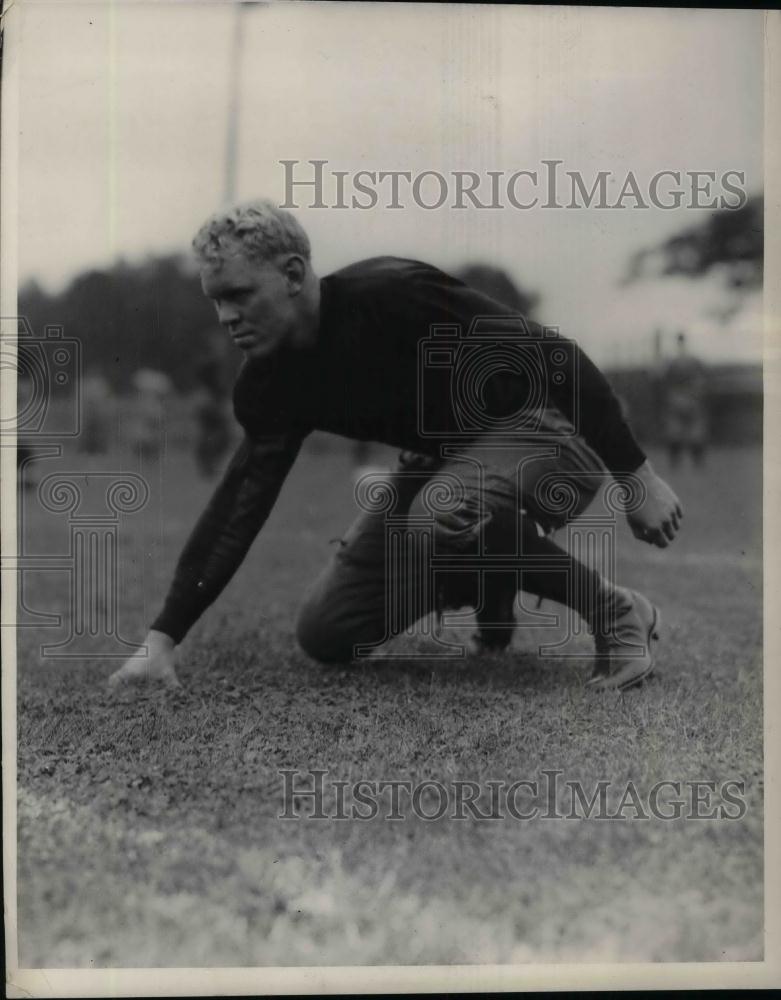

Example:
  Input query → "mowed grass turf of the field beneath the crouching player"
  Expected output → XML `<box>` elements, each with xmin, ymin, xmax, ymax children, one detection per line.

<box><xmin>18</xmin><ymin>444</ymin><xmax>763</xmax><ymax>967</ymax></box>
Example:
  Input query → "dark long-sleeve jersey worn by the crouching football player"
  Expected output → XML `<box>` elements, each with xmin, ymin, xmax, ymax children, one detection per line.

<box><xmin>152</xmin><ymin>257</ymin><xmax>645</xmax><ymax>642</ymax></box>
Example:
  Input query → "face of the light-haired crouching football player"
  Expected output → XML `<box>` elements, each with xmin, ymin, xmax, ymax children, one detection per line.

<box><xmin>201</xmin><ymin>253</ymin><xmax>296</xmax><ymax>358</ymax></box>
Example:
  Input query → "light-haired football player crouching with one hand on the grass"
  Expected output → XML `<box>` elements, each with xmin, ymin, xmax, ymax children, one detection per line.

<box><xmin>111</xmin><ymin>201</ymin><xmax>682</xmax><ymax>690</ymax></box>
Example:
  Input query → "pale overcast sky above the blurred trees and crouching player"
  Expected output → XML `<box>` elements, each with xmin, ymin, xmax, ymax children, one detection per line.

<box><xmin>7</xmin><ymin>0</ymin><xmax>763</xmax><ymax>363</ymax></box>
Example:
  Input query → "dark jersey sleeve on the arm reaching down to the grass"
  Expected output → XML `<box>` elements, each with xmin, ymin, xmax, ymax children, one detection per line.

<box><xmin>151</xmin><ymin>432</ymin><xmax>303</xmax><ymax>643</ymax></box>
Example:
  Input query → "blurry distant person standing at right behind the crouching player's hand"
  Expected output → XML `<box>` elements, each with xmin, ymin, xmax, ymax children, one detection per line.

<box><xmin>661</xmin><ymin>333</ymin><xmax>708</xmax><ymax>466</ymax></box>
